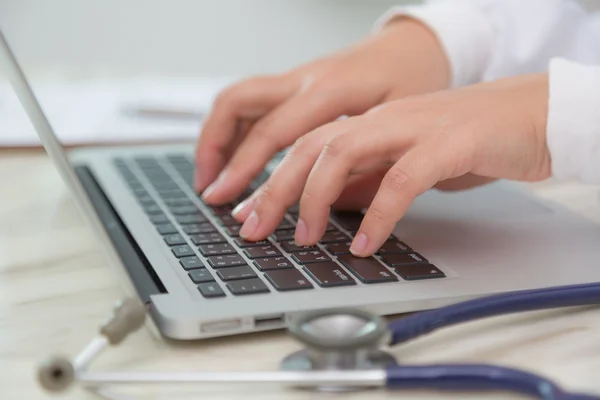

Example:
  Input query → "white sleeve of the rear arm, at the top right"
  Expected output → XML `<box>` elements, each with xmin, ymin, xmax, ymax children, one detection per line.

<box><xmin>376</xmin><ymin>0</ymin><xmax>600</xmax><ymax>87</ymax></box>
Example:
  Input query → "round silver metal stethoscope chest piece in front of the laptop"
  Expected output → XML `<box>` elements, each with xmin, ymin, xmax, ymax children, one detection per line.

<box><xmin>280</xmin><ymin>309</ymin><xmax>396</xmax><ymax>391</ymax></box>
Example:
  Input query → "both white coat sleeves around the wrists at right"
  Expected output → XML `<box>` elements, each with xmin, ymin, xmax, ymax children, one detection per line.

<box><xmin>376</xmin><ymin>0</ymin><xmax>600</xmax><ymax>183</ymax></box>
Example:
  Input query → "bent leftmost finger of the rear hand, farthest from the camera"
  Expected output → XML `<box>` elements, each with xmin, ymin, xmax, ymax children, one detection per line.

<box><xmin>195</xmin><ymin>76</ymin><xmax>299</xmax><ymax>192</ymax></box>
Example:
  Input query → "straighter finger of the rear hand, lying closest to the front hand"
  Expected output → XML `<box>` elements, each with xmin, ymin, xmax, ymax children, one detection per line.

<box><xmin>204</xmin><ymin>83</ymin><xmax>360</xmax><ymax>203</ymax></box>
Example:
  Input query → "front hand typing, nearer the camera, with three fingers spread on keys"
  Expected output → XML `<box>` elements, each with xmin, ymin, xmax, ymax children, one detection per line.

<box><xmin>234</xmin><ymin>74</ymin><xmax>550</xmax><ymax>256</ymax></box>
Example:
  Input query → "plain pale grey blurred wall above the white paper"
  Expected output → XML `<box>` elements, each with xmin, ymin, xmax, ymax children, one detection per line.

<box><xmin>0</xmin><ymin>0</ymin><xmax>408</xmax><ymax>75</ymax></box>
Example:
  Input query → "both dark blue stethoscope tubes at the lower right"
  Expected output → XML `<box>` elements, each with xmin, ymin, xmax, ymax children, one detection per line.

<box><xmin>386</xmin><ymin>283</ymin><xmax>600</xmax><ymax>400</ymax></box>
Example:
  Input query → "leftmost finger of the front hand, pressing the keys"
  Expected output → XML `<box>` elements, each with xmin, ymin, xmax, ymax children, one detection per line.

<box><xmin>235</xmin><ymin>118</ymin><xmax>354</xmax><ymax>240</ymax></box>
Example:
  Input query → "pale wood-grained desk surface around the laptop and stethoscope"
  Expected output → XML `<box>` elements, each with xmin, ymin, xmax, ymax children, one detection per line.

<box><xmin>0</xmin><ymin>151</ymin><xmax>600</xmax><ymax>400</ymax></box>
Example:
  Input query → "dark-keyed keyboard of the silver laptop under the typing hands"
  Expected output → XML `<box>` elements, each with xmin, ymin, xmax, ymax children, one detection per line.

<box><xmin>114</xmin><ymin>154</ymin><xmax>445</xmax><ymax>299</ymax></box>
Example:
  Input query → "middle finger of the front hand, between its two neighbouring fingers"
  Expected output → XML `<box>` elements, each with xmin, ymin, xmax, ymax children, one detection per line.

<box><xmin>297</xmin><ymin>126</ymin><xmax>413</xmax><ymax>245</ymax></box>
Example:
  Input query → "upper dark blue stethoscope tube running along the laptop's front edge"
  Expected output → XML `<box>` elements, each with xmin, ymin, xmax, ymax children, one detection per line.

<box><xmin>389</xmin><ymin>283</ymin><xmax>600</xmax><ymax>345</ymax></box>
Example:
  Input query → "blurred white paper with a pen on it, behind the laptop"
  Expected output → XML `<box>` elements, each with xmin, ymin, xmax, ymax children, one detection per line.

<box><xmin>0</xmin><ymin>78</ymin><xmax>231</xmax><ymax>146</ymax></box>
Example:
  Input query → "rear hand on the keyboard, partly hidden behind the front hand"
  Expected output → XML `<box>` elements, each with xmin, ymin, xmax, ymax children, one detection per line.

<box><xmin>195</xmin><ymin>18</ymin><xmax>450</xmax><ymax>204</ymax></box>
